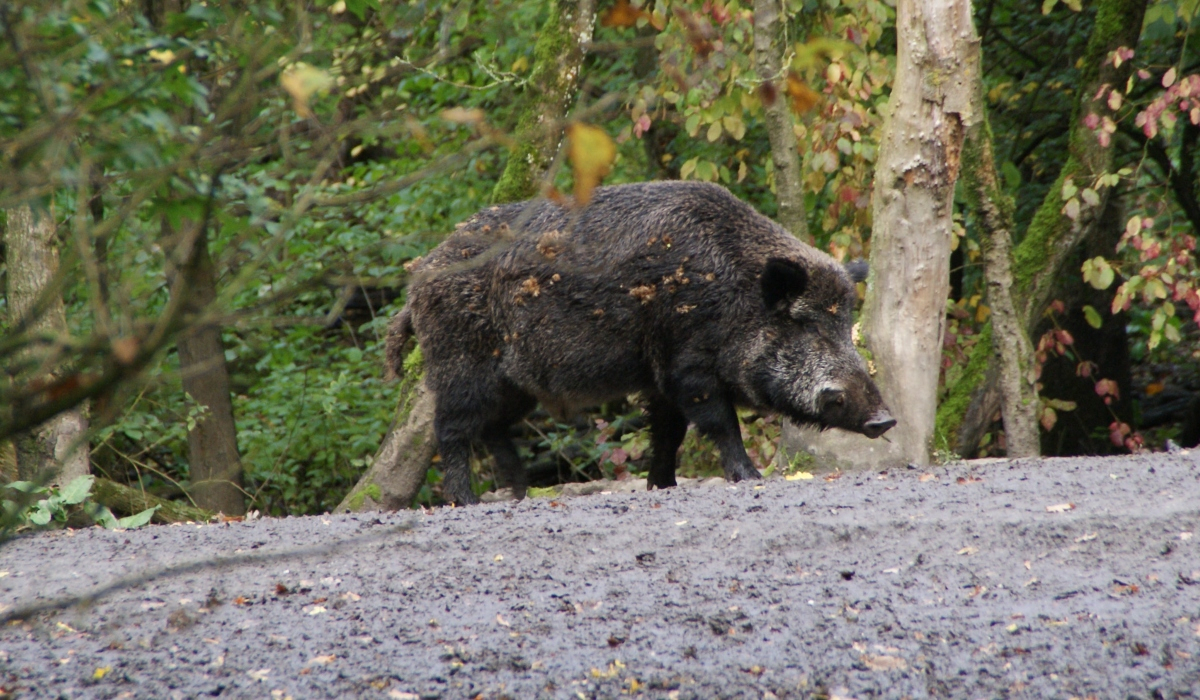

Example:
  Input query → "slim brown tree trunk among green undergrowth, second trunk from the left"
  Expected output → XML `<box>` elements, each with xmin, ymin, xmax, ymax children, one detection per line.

<box><xmin>163</xmin><ymin>222</ymin><xmax>246</xmax><ymax>515</ymax></box>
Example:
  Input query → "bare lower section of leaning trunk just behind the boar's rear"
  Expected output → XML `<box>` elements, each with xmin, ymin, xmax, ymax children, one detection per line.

<box><xmin>334</xmin><ymin>349</ymin><xmax>437</xmax><ymax>513</ymax></box>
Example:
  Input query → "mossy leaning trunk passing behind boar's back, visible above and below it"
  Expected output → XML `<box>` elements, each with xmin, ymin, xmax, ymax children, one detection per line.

<box><xmin>335</xmin><ymin>0</ymin><xmax>595</xmax><ymax>513</ymax></box>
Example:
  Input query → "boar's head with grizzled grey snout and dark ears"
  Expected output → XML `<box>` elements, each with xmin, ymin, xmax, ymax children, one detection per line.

<box><xmin>750</xmin><ymin>258</ymin><xmax>896</xmax><ymax>438</ymax></box>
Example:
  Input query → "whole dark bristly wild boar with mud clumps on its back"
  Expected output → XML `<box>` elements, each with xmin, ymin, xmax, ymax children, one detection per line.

<box><xmin>388</xmin><ymin>181</ymin><xmax>895</xmax><ymax>504</ymax></box>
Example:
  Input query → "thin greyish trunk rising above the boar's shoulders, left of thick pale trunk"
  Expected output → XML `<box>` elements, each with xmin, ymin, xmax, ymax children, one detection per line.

<box><xmin>754</xmin><ymin>0</ymin><xmax>812</xmax><ymax>243</ymax></box>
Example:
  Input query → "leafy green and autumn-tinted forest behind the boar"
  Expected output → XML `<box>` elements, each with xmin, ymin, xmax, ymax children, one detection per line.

<box><xmin>0</xmin><ymin>0</ymin><xmax>1200</xmax><ymax>525</ymax></box>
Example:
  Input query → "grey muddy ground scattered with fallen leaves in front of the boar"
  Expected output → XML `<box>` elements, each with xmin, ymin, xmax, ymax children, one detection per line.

<box><xmin>0</xmin><ymin>453</ymin><xmax>1200</xmax><ymax>700</ymax></box>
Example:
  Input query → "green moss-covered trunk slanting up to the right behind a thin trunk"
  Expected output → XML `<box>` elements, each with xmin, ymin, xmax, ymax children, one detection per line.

<box><xmin>937</xmin><ymin>0</ymin><xmax>1146</xmax><ymax>454</ymax></box>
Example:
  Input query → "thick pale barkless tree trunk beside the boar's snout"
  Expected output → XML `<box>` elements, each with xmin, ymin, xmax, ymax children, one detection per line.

<box><xmin>863</xmin><ymin>0</ymin><xmax>978</xmax><ymax>465</ymax></box>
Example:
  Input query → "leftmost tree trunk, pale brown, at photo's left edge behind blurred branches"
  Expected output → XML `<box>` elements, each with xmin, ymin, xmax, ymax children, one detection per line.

<box><xmin>5</xmin><ymin>204</ymin><xmax>90</xmax><ymax>484</ymax></box>
